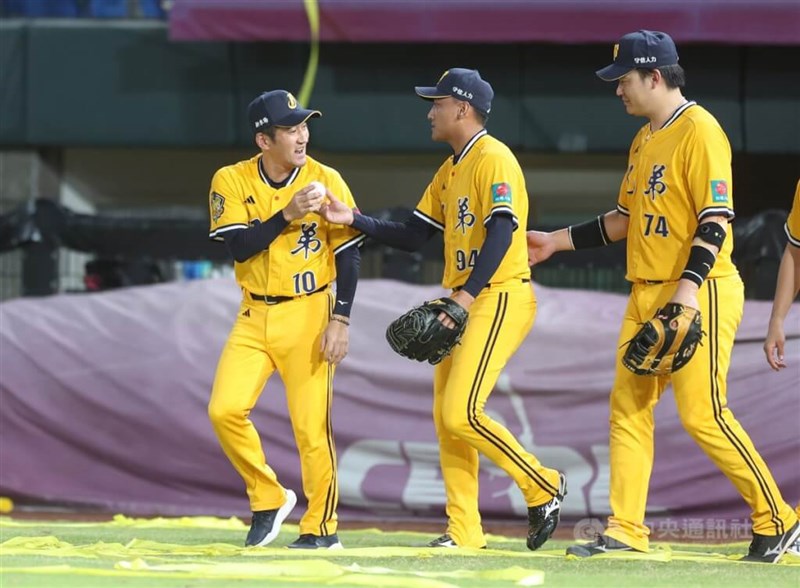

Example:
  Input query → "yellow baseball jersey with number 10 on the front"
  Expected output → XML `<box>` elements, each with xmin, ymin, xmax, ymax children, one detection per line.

<box><xmin>209</xmin><ymin>155</ymin><xmax>364</xmax><ymax>296</ymax></box>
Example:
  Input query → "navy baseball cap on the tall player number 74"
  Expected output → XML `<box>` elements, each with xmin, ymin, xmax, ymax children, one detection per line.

<box><xmin>595</xmin><ymin>31</ymin><xmax>678</xmax><ymax>82</ymax></box>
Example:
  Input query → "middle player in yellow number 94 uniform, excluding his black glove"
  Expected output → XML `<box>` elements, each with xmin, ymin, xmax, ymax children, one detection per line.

<box><xmin>320</xmin><ymin>68</ymin><xmax>566</xmax><ymax>549</ymax></box>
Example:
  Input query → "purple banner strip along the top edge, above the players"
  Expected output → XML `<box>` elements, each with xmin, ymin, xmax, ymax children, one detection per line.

<box><xmin>169</xmin><ymin>0</ymin><xmax>800</xmax><ymax>45</ymax></box>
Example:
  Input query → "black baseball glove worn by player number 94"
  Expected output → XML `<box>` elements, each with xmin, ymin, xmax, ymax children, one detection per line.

<box><xmin>386</xmin><ymin>298</ymin><xmax>467</xmax><ymax>365</ymax></box>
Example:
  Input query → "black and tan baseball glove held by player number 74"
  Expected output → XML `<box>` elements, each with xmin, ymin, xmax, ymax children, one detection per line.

<box><xmin>622</xmin><ymin>302</ymin><xmax>703</xmax><ymax>376</ymax></box>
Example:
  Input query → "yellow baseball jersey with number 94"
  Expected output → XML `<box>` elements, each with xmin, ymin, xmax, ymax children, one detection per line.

<box><xmin>414</xmin><ymin>130</ymin><xmax>530</xmax><ymax>289</ymax></box>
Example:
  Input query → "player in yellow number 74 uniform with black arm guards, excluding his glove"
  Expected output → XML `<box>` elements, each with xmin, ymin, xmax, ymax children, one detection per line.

<box><xmin>528</xmin><ymin>31</ymin><xmax>800</xmax><ymax>562</ymax></box>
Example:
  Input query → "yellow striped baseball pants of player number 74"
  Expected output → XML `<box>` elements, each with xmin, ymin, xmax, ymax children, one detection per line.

<box><xmin>606</xmin><ymin>275</ymin><xmax>797</xmax><ymax>551</ymax></box>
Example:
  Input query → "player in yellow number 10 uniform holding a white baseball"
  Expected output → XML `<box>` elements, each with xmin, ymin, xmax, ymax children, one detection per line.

<box><xmin>208</xmin><ymin>90</ymin><xmax>364</xmax><ymax>549</ymax></box>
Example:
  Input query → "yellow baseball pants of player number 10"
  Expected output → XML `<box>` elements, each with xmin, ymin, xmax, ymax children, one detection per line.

<box><xmin>208</xmin><ymin>290</ymin><xmax>339</xmax><ymax>535</ymax></box>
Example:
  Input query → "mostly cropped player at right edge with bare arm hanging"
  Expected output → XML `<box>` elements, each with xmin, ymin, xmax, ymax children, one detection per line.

<box><xmin>764</xmin><ymin>181</ymin><xmax>800</xmax><ymax>557</ymax></box>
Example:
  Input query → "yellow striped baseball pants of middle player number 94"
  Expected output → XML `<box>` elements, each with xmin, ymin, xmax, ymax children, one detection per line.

<box><xmin>433</xmin><ymin>280</ymin><xmax>559</xmax><ymax>548</ymax></box>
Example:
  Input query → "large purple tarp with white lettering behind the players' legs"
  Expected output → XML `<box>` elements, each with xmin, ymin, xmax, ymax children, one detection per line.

<box><xmin>0</xmin><ymin>279</ymin><xmax>800</xmax><ymax>520</ymax></box>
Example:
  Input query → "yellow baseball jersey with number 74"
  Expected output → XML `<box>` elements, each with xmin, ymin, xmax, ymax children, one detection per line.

<box><xmin>617</xmin><ymin>102</ymin><xmax>737</xmax><ymax>282</ymax></box>
